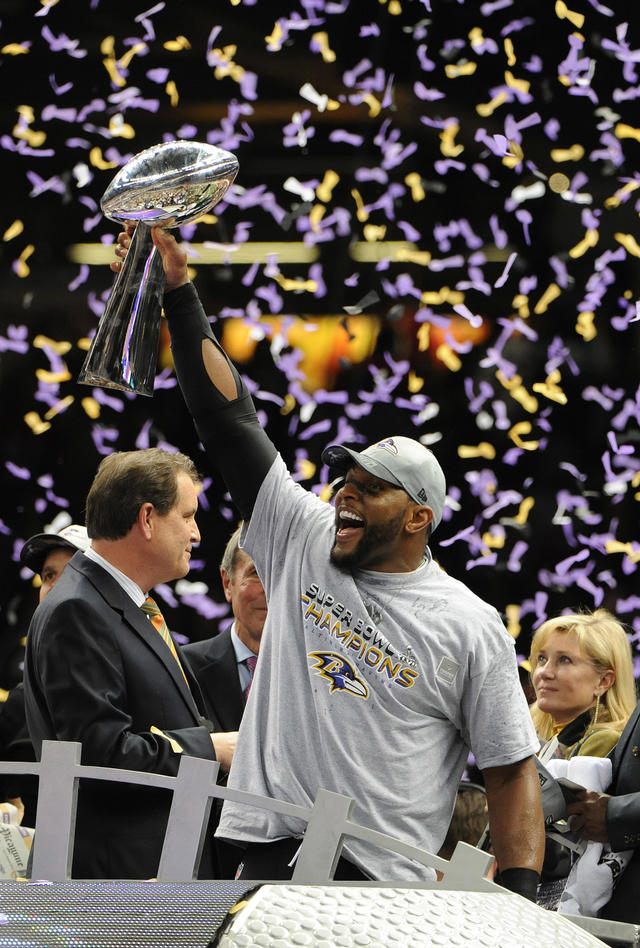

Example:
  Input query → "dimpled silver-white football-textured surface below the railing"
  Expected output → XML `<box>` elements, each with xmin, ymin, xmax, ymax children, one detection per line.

<box><xmin>213</xmin><ymin>885</ymin><xmax>603</xmax><ymax>948</ymax></box>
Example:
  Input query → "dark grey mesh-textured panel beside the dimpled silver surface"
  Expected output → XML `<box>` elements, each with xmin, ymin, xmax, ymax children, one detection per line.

<box><xmin>0</xmin><ymin>882</ymin><xmax>247</xmax><ymax>948</ymax></box>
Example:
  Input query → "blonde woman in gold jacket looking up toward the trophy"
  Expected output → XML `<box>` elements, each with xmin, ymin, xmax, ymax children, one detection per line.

<box><xmin>529</xmin><ymin>609</ymin><xmax>636</xmax><ymax>759</ymax></box>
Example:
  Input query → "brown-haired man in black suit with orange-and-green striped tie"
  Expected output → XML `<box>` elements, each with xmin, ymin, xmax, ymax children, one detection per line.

<box><xmin>24</xmin><ymin>448</ymin><xmax>235</xmax><ymax>879</ymax></box>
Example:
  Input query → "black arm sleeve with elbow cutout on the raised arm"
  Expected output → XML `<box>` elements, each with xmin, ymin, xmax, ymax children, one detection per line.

<box><xmin>164</xmin><ymin>283</ymin><xmax>277</xmax><ymax>520</ymax></box>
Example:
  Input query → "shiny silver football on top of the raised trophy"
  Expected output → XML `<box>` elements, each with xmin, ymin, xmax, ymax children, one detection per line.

<box><xmin>100</xmin><ymin>140</ymin><xmax>238</xmax><ymax>227</ymax></box>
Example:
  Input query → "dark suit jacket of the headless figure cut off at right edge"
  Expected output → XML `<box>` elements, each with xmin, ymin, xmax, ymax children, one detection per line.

<box><xmin>599</xmin><ymin>705</ymin><xmax>640</xmax><ymax>924</ymax></box>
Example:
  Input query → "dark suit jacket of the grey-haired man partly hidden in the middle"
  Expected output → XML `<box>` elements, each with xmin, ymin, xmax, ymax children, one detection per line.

<box><xmin>182</xmin><ymin>629</ymin><xmax>244</xmax><ymax>731</ymax></box>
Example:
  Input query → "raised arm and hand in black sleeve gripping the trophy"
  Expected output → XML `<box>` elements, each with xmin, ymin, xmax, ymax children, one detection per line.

<box><xmin>112</xmin><ymin>227</ymin><xmax>277</xmax><ymax>520</ymax></box>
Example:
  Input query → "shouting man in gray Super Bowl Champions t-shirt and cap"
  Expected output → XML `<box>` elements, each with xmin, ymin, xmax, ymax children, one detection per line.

<box><xmin>113</xmin><ymin>228</ymin><xmax>544</xmax><ymax>898</ymax></box>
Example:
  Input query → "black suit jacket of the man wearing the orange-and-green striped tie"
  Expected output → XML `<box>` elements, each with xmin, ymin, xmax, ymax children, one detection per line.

<box><xmin>24</xmin><ymin>553</ymin><xmax>215</xmax><ymax>879</ymax></box>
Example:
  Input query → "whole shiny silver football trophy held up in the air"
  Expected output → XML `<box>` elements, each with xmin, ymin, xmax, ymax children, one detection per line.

<box><xmin>78</xmin><ymin>141</ymin><xmax>238</xmax><ymax>395</ymax></box>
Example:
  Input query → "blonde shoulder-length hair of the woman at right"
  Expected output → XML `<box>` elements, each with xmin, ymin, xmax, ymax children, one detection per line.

<box><xmin>529</xmin><ymin>609</ymin><xmax>636</xmax><ymax>741</ymax></box>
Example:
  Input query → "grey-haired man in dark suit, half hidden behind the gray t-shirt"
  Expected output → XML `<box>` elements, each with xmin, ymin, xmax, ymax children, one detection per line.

<box><xmin>182</xmin><ymin>528</ymin><xmax>267</xmax><ymax>731</ymax></box>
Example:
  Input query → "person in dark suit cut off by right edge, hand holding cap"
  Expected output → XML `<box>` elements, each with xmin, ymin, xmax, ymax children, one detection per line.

<box><xmin>567</xmin><ymin>705</ymin><xmax>640</xmax><ymax>924</ymax></box>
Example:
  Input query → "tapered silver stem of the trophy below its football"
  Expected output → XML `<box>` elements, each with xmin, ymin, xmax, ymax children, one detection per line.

<box><xmin>78</xmin><ymin>223</ymin><xmax>164</xmax><ymax>396</ymax></box>
